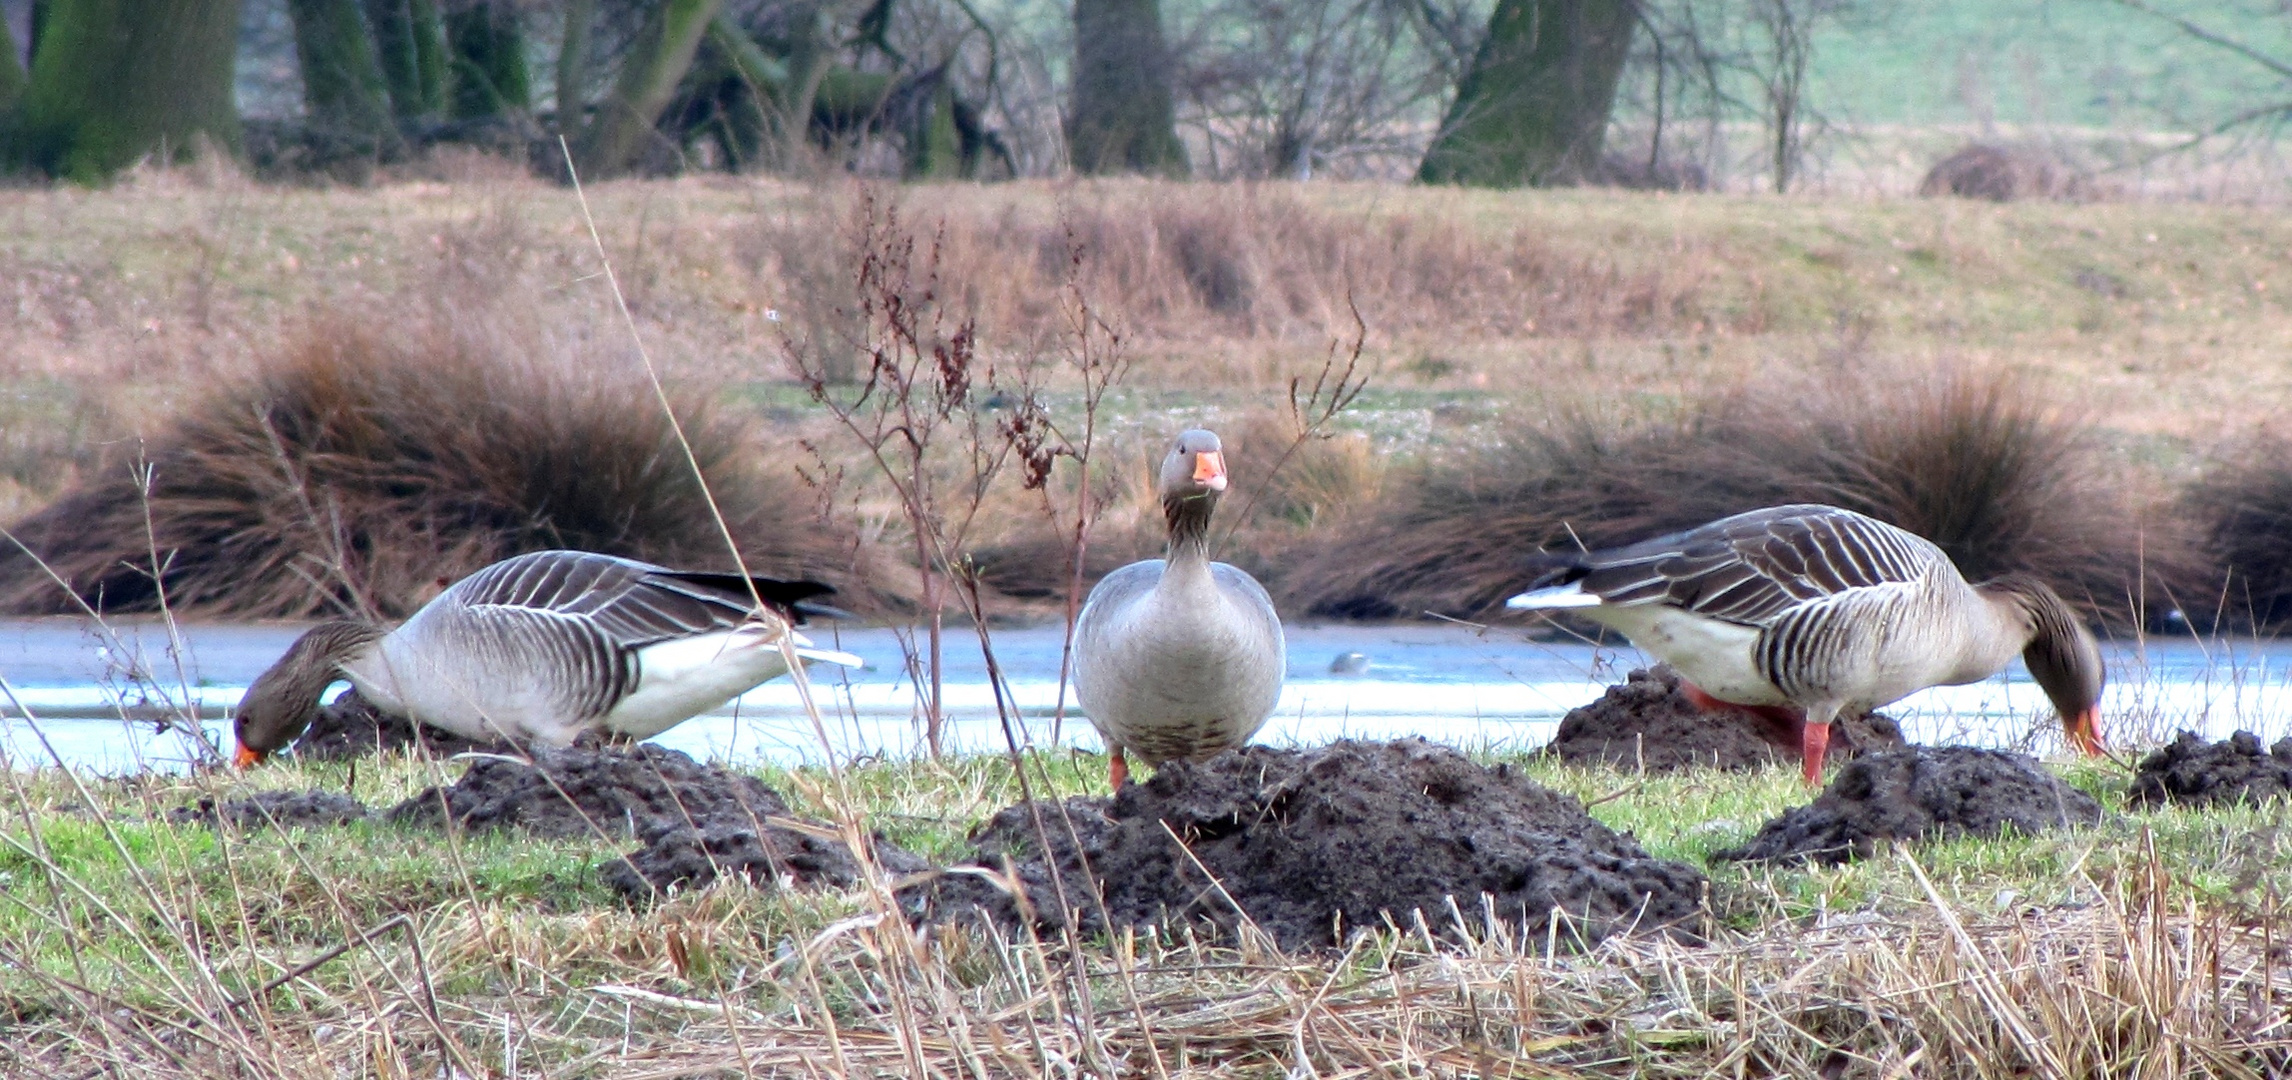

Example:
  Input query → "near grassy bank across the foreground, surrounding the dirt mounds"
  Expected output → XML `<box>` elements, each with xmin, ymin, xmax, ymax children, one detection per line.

<box><xmin>0</xmin><ymin>754</ymin><xmax>2292</xmax><ymax>1078</ymax></box>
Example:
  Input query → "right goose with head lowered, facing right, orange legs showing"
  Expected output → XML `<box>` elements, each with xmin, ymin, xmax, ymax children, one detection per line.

<box><xmin>1506</xmin><ymin>507</ymin><xmax>2102</xmax><ymax>784</ymax></box>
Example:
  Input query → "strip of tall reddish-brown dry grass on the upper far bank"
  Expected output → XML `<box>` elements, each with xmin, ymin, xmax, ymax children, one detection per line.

<box><xmin>745</xmin><ymin>181</ymin><xmax>1732</xmax><ymax>353</ymax></box>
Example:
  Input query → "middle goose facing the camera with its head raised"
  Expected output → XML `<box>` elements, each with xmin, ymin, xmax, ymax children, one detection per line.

<box><xmin>1075</xmin><ymin>431</ymin><xmax>1288</xmax><ymax>791</ymax></box>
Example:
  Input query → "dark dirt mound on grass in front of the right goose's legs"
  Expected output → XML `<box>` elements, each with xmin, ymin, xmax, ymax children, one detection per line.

<box><xmin>1712</xmin><ymin>745</ymin><xmax>2102</xmax><ymax>864</ymax></box>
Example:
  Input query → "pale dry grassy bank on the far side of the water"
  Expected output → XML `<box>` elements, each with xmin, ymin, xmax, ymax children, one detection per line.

<box><xmin>0</xmin><ymin>174</ymin><xmax>2292</xmax><ymax>621</ymax></box>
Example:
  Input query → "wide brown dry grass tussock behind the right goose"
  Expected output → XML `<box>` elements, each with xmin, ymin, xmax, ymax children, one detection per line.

<box><xmin>1274</xmin><ymin>374</ymin><xmax>2182</xmax><ymax>624</ymax></box>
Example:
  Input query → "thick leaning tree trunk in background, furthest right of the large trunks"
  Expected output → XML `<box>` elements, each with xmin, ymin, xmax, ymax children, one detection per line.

<box><xmin>1416</xmin><ymin>0</ymin><xmax>1639</xmax><ymax>188</ymax></box>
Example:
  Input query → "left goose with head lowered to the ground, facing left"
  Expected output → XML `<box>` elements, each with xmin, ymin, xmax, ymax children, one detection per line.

<box><xmin>234</xmin><ymin>550</ymin><xmax>862</xmax><ymax>768</ymax></box>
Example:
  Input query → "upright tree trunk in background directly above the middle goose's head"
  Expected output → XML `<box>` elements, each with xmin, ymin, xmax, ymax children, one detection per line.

<box><xmin>1066</xmin><ymin>0</ymin><xmax>1187</xmax><ymax>177</ymax></box>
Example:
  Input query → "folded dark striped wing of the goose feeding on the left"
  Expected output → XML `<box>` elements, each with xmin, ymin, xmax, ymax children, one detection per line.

<box><xmin>440</xmin><ymin>550</ymin><xmax>834</xmax><ymax>649</ymax></box>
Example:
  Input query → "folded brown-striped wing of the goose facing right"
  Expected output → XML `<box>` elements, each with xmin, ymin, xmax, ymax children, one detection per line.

<box><xmin>1522</xmin><ymin>504</ymin><xmax>1948</xmax><ymax>626</ymax></box>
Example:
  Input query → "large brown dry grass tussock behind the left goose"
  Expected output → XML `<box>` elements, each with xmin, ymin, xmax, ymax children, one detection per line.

<box><xmin>0</xmin><ymin>316</ymin><xmax>864</xmax><ymax>617</ymax></box>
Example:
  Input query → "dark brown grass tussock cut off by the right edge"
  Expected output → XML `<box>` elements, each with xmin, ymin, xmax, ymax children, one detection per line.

<box><xmin>2180</xmin><ymin>436</ymin><xmax>2292</xmax><ymax>631</ymax></box>
